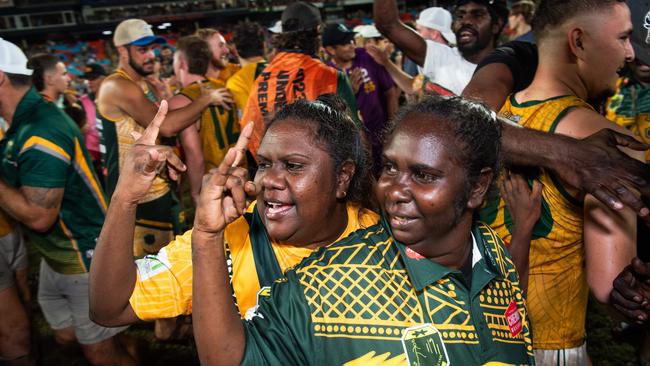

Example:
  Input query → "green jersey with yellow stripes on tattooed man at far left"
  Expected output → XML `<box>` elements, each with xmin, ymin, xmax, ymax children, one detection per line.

<box><xmin>0</xmin><ymin>88</ymin><xmax>107</xmax><ymax>274</ymax></box>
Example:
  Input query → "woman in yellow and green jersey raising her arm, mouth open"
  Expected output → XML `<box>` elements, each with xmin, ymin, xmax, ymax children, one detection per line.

<box><xmin>91</xmin><ymin>96</ymin><xmax>378</xmax><ymax>325</ymax></box>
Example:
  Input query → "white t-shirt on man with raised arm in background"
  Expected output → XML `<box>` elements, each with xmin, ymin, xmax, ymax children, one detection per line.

<box><xmin>418</xmin><ymin>40</ymin><xmax>476</xmax><ymax>95</ymax></box>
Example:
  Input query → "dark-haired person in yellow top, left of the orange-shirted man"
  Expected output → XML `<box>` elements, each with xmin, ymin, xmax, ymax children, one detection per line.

<box><xmin>226</xmin><ymin>21</ymin><xmax>268</xmax><ymax>119</ymax></box>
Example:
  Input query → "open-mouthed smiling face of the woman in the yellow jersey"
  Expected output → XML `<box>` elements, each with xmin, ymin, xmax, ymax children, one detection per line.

<box><xmin>255</xmin><ymin>119</ymin><xmax>347</xmax><ymax>245</ymax></box>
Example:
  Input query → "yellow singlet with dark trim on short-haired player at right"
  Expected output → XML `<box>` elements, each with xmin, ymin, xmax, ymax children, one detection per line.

<box><xmin>480</xmin><ymin>95</ymin><xmax>592</xmax><ymax>349</ymax></box>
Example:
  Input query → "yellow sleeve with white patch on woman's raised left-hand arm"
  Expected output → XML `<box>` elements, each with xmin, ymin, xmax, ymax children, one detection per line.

<box><xmin>129</xmin><ymin>230</ymin><xmax>192</xmax><ymax>320</ymax></box>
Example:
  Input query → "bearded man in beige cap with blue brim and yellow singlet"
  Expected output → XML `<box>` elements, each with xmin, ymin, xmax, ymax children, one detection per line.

<box><xmin>97</xmin><ymin>19</ymin><xmax>231</xmax><ymax>256</ymax></box>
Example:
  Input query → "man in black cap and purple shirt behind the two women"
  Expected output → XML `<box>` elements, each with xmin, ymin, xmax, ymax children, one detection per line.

<box><xmin>323</xmin><ymin>24</ymin><xmax>399</xmax><ymax>173</ymax></box>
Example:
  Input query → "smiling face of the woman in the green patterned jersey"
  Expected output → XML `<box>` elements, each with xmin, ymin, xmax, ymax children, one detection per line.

<box><xmin>376</xmin><ymin>115</ymin><xmax>469</xmax><ymax>257</ymax></box>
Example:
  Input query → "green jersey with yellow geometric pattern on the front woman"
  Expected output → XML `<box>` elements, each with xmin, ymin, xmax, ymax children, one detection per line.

<box><xmin>242</xmin><ymin>222</ymin><xmax>534</xmax><ymax>365</ymax></box>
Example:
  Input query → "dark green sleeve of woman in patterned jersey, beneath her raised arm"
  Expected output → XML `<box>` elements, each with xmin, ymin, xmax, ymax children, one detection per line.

<box><xmin>241</xmin><ymin>271</ymin><xmax>319</xmax><ymax>365</ymax></box>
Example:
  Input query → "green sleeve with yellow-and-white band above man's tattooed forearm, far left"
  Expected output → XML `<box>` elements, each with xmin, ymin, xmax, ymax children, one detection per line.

<box><xmin>18</xmin><ymin>135</ymin><xmax>74</xmax><ymax>188</ymax></box>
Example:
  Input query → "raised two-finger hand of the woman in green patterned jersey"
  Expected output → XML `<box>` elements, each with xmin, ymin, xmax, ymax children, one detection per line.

<box><xmin>194</xmin><ymin>123</ymin><xmax>255</xmax><ymax>235</ymax></box>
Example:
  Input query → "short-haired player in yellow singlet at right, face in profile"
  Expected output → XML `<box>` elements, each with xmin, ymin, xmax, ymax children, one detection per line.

<box><xmin>481</xmin><ymin>0</ymin><xmax>641</xmax><ymax>365</ymax></box>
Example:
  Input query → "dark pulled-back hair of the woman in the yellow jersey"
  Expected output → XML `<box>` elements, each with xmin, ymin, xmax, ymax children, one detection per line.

<box><xmin>267</xmin><ymin>94</ymin><xmax>374</xmax><ymax>208</ymax></box>
